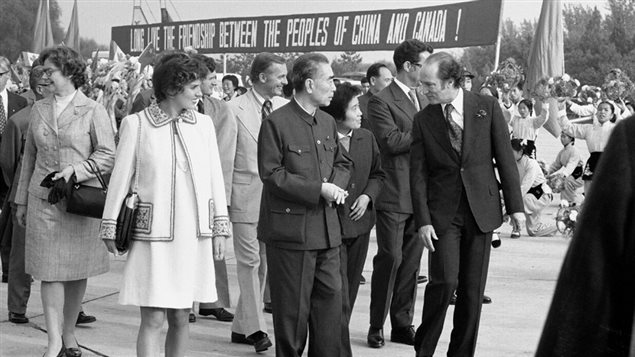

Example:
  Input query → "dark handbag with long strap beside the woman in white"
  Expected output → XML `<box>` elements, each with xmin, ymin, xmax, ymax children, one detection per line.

<box><xmin>115</xmin><ymin>115</ymin><xmax>141</xmax><ymax>253</ymax></box>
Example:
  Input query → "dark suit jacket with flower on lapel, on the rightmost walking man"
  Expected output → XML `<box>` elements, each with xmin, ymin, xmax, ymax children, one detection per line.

<box><xmin>410</xmin><ymin>91</ymin><xmax>524</xmax><ymax>235</ymax></box>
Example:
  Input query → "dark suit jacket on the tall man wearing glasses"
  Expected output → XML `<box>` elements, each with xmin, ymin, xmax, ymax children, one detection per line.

<box><xmin>368</xmin><ymin>81</ymin><xmax>427</xmax><ymax>213</ymax></box>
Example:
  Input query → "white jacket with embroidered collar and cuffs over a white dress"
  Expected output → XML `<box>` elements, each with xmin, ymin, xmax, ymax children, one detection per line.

<box><xmin>100</xmin><ymin>104</ymin><xmax>229</xmax><ymax>241</ymax></box>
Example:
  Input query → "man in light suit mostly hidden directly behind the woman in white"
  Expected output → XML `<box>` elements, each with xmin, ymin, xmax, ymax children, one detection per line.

<box><xmin>193</xmin><ymin>55</ymin><xmax>238</xmax><ymax>321</ymax></box>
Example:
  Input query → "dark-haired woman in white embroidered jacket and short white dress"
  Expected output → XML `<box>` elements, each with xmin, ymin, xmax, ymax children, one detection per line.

<box><xmin>100</xmin><ymin>54</ymin><xmax>229</xmax><ymax>356</ymax></box>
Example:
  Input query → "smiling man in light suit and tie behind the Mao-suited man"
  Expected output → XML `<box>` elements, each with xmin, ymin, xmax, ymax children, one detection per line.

<box><xmin>229</xmin><ymin>53</ymin><xmax>288</xmax><ymax>352</ymax></box>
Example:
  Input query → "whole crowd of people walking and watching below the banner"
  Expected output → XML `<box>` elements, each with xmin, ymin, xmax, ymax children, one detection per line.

<box><xmin>0</xmin><ymin>36</ymin><xmax>632</xmax><ymax>357</ymax></box>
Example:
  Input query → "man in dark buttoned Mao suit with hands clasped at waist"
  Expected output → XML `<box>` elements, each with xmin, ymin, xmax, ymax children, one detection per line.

<box><xmin>258</xmin><ymin>53</ymin><xmax>352</xmax><ymax>357</ymax></box>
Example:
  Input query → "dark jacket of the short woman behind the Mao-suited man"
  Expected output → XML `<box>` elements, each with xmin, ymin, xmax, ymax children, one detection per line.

<box><xmin>337</xmin><ymin>128</ymin><xmax>386</xmax><ymax>238</ymax></box>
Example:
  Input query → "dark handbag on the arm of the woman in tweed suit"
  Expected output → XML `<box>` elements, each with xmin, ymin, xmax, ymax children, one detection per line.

<box><xmin>66</xmin><ymin>159</ymin><xmax>108</xmax><ymax>219</ymax></box>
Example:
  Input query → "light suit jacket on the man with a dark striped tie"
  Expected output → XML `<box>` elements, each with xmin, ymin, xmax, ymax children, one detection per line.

<box><xmin>228</xmin><ymin>89</ymin><xmax>289</xmax><ymax>223</ymax></box>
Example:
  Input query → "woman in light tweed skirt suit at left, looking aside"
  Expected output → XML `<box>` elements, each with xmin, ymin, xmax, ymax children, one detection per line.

<box><xmin>15</xmin><ymin>46</ymin><xmax>115</xmax><ymax>357</ymax></box>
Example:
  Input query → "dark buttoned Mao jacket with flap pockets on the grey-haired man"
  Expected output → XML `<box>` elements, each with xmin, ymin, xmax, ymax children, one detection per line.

<box><xmin>258</xmin><ymin>100</ymin><xmax>352</xmax><ymax>250</ymax></box>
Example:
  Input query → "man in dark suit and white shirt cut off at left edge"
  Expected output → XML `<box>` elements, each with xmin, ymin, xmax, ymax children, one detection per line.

<box><xmin>0</xmin><ymin>56</ymin><xmax>27</xmax><ymax>283</ymax></box>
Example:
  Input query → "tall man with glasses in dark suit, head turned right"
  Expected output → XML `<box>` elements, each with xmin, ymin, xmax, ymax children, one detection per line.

<box><xmin>367</xmin><ymin>40</ymin><xmax>433</xmax><ymax>348</ymax></box>
